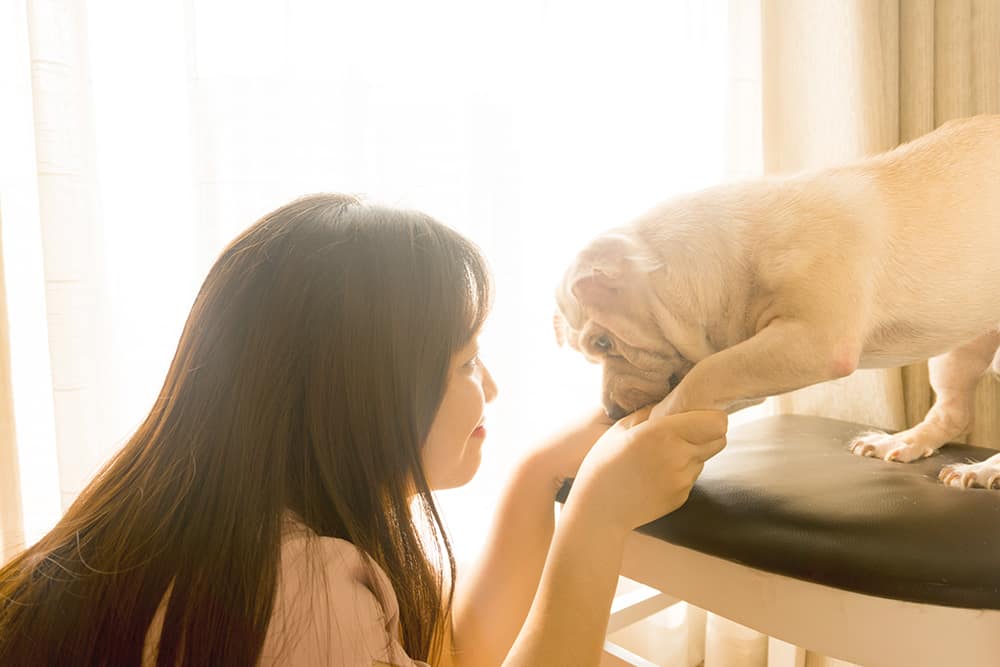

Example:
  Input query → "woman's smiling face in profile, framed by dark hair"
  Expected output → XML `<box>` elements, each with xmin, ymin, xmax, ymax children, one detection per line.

<box><xmin>422</xmin><ymin>337</ymin><xmax>497</xmax><ymax>489</ymax></box>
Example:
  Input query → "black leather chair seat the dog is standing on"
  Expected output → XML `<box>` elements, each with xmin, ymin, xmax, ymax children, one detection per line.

<box><xmin>560</xmin><ymin>415</ymin><xmax>1000</xmax><ymax>609</ymax></box>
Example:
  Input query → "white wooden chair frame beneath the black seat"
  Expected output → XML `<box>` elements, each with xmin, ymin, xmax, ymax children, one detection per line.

<box><xmin>601</xmin><ymin>533</ymin><xmax>1000</xmax><ymax>667</ymax></box>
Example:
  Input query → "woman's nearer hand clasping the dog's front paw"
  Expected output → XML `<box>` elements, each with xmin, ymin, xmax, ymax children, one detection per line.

<box><xmin>570</xmin><ymin>408</ymin><xmax>728</xmax><ymax>531</ymax></box>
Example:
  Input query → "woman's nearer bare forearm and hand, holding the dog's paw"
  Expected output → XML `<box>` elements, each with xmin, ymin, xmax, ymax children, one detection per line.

<box><xmin>500</xmin><ymin>409</ymin><xmax>727</xmax><ymax>667</ymax></box>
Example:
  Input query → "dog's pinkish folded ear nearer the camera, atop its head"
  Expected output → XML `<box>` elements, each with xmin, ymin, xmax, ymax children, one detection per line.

<box><xmin>569</xmin><ymin>233</ymin><xmax>659</xmax><ymax>308</ymax></box>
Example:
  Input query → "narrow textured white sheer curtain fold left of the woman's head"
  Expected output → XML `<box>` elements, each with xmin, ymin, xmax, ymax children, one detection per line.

<box><xmin>29</xmin><ymin>0</ymin><xmax>112</xmax><ymax>509</ymax></box>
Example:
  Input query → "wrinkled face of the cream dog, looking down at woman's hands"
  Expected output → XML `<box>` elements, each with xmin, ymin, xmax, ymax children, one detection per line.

<box><xmin>553</xmin><ymin>233</ymin><xmax>693</xmax><ymax>419</ymax></box>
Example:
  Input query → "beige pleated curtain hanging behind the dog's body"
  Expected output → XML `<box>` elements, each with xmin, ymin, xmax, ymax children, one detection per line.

<box><xmin>724</xmin><ymin>0</ymin><xmax>1000</xmax><ymax>667</ymax></box>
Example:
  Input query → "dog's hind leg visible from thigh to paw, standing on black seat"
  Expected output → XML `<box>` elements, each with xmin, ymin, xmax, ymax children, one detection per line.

<box><xmin>850</xmin><ymin>331</ymin><xmax>1000</xmax><ymax>462</ymax></box>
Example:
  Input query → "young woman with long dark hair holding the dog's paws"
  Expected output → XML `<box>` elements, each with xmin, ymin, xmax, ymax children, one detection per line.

<box><xmin>0</xmin><ymin>190</ymin><xmax>726</xmax><ymax>667</ymax></box>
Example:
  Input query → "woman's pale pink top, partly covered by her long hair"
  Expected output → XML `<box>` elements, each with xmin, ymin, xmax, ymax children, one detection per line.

<box><xmin>143</xmin><ymin>522</ymin><xmax>428</xmax><ymax>667</ymax></box>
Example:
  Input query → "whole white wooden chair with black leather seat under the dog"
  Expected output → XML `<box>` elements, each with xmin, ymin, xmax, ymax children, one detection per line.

<box><xmin>564</xmin><ymin>415</ymin><xmax>1000</xmax><ymax>667</ymax></box>
